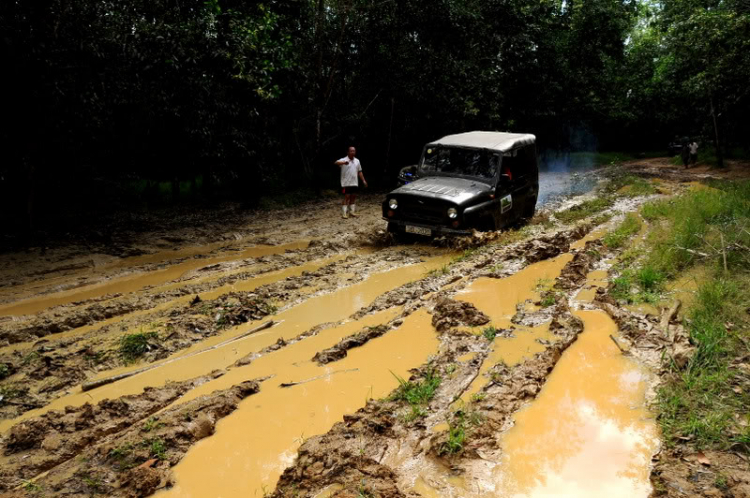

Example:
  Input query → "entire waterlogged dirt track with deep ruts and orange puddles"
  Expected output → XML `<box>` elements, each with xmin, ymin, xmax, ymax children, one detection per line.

<box><xmin>0</xmin><ymin>160</ymin><xmax>748</xmax><ymax>497</ymax></box>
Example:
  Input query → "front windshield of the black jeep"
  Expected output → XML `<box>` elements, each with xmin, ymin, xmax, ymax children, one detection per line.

<box><xmin>419</xmin><ymin>147</ymin><xmax>498</xmax><ymax>180</ymax></box>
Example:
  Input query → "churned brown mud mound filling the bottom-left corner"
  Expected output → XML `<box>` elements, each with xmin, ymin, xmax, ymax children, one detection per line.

<box><xmin>0</xmin><ymin>378</ymin><xmax>259</xmax><ymax>497</ymax></box>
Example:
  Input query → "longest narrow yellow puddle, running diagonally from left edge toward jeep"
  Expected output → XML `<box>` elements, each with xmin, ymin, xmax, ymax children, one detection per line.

<box><xmin>0</xmin><ymin>253</ymin><xmax>452</xmax><ymax>432</ymax></box>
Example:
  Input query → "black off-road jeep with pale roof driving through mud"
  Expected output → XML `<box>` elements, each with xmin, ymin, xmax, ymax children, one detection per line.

<box><xmin>383</xmin><ymin>131</ymin><xmax>539</xmax><ymax>236</ymax></box>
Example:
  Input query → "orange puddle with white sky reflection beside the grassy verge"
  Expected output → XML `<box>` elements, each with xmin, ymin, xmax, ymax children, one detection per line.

<box><xmin>415</xmin><ymin>310</ymin><xmax>659</xmax><ymax>498</ymax></box>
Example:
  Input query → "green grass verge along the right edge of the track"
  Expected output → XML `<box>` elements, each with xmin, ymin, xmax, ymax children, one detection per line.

<box><xmin>628</xmin><ymin>181</ymin><xmax>750</xmax><ymax>454</ymax></box>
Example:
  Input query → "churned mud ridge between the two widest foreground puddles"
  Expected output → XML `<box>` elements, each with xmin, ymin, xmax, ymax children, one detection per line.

<box><xmin>273</xmin><ymin>231</ymin><xmax>612</xmax><ymax>497</ymax></box>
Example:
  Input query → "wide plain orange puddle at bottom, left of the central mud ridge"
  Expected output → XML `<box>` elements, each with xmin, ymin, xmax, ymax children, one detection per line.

<box><xmin>158</xmin><ymin>310</ymin><xmax>438</xmax><ymax>497</ymax></box>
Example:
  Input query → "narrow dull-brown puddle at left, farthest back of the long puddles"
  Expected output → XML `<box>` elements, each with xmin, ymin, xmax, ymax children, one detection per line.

<box><xmin>0</xmin><ymin>241</ymin><xmax>309</xmax><ymax>316</ymax></box>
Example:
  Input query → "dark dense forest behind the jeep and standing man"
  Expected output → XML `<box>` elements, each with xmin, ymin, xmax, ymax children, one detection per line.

<box><xmin>0</xmin><ymin>0</ymin><xmax>750</xmax><ymax>230</ymax></box>
